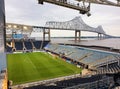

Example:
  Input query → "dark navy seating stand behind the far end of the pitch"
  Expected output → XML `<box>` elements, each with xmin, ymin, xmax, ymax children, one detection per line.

<box><xmin>6</xmin><ymin>39</ymin><xmax>49</xmax><ymax>52</ymax></box>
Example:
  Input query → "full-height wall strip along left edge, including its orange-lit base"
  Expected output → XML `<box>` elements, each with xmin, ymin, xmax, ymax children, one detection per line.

<box><xmin>0</xmin><ymin>0</ymin><xmax>7</xmax><ymax>89</ymax></box>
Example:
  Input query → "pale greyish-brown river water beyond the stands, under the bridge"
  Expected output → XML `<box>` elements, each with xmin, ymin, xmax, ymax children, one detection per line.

<box><xmin>51</xmin><ymin>38</ymin><xmax>120</xmax><ymax>49</ymax></box>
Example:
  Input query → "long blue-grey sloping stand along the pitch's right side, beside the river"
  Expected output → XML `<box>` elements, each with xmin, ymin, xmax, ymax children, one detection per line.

<box><xmin>45</xmin><ymin>44</ymin><xmax>118</xmax><ymax>67</ymax></box>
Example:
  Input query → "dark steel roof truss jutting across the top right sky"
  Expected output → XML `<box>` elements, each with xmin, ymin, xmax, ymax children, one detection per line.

<box><xmin>38</xmin><ymin>0</ymin><xmax>120</xmax><ymax>16</ymax></box>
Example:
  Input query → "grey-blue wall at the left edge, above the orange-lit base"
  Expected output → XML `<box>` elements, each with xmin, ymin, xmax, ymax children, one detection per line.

<box><xmin>0</xmin><ymin>0</ymin><xmax>6</xmax><ymax>71</ymax></box>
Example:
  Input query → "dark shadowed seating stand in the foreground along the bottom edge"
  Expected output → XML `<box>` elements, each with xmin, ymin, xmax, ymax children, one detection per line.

<box><xmin>24</xmin><ymin>75</ymin><xmax>112</xmax><ymax>89</ymax></box>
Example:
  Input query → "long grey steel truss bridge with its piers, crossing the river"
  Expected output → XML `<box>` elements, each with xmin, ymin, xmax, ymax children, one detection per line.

<box><xmin>33</xmin><ymin>17</ymin><xmax>109</xmax><ymax>42</ymax></box>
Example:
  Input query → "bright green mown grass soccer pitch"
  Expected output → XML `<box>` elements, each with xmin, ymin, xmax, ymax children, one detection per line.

<box><xmin>7</xmin><ymin>52</ymin><xmax>81</xmax><ymax>85</ymax></box>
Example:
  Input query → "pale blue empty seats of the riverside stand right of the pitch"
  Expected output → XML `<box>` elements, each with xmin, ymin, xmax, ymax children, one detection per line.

<box><xmin>46</xmin><ymin>44</ymin><xmax>112</xmax><ymax>65</ymax></box>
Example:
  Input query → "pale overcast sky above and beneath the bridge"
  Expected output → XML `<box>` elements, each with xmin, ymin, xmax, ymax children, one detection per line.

<box><xmin>5</xmin><ymin>0</ymin><xmax>120</xmax><ymax>36</ymax></box>
